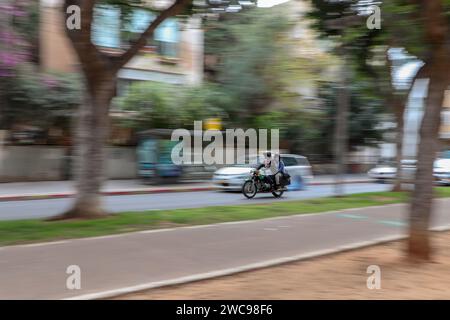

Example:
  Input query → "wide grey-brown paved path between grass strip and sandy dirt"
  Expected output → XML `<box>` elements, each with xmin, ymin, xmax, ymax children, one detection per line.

<box><xmin>0</xmin><ymin>199</ymin><xmax>450</xmax><ymax>299</ymax></box>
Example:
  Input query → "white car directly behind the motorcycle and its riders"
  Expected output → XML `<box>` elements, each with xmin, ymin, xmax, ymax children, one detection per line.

<box><xmin>212</xmin><ymin>154</ymin><xmax>313</xmax><ymax>191</ymax></box>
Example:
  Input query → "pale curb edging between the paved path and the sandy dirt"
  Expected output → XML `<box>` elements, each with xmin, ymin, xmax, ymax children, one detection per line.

<box><xmin>63</xmin><ymin>225</ymin><xmax>450</xmax><ymax>300</ymax></box>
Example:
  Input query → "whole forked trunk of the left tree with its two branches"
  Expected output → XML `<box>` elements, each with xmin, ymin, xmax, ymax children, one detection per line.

<box><xmin>57</xmin><ymin>0</ymin><xmax>189</xmax><ymax>220</ymax></box>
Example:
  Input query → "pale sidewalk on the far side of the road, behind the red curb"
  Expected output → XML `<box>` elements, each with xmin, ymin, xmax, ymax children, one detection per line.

<box><xmin>0</xmin><ymin>174</ymin><xmax>372</xmax><ymax>201</ymax></box>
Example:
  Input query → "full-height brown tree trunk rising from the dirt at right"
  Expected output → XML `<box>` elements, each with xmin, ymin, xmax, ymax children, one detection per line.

<box><xmin>408</xmin><ymin>0</ymin><xmax>450</xmax><ymax>261</ymax></box>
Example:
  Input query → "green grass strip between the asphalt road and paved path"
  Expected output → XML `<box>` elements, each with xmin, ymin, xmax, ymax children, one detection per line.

<box><xmin>0</xmin><ymin>187</ymin><xmax>450</xmax><ymax>245</ymax></box>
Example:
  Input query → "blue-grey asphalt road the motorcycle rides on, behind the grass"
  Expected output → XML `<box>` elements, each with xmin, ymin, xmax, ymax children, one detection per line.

<box><xmin>0</xmin><ymin>183</ymin><xmax>390</xmax><ymax>220</ymax></box>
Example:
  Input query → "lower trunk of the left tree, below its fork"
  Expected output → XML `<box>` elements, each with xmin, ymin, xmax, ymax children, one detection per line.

<box><xmin>57</xmin><ymin>81</ymin><xmax>114</xmax><ymax>219</ymax></box>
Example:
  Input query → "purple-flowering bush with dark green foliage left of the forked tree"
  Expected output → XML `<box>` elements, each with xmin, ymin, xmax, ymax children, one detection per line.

<box><xmin>0</xmin><ymin>0</ymin><xmax>81</xmax><ymax>130</ymax></box>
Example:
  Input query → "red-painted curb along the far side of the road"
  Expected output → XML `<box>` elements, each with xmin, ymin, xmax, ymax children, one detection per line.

<box><xmin>0</xmin><ymin>180</ymin><xmax>373</xmax><ymax>202</ymax></box>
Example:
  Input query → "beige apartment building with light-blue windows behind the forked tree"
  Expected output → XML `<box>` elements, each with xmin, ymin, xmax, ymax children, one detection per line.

<box><xmin>40</xmin><ymin>0</ymin><xmax>203</xmax><ymax>91</ymax></box>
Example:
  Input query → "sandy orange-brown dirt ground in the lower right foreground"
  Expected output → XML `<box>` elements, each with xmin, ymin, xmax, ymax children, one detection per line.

<box><xmin>118</xmin><ymin>232</ymin><xmax>450</xmax><ymax>300</ymax></box>
